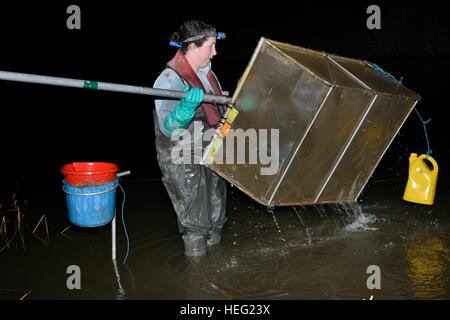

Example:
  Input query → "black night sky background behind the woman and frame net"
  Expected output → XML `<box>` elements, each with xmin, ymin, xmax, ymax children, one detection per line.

<box><xmin>0</xmin><ymin>1</ymin><xmax>450</xmax><ymax>188</ymax></box>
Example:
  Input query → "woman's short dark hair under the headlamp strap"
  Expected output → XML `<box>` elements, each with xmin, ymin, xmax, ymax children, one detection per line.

<box><xmin>170</xmin><ymin>20</ymin><xmax>216</xmax><ymax>54</ymax></box>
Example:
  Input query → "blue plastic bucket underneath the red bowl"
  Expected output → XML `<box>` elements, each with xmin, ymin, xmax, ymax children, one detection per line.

<box><xmin>63</xmin><ymin>179</ymin><xmax>118</xmax><ymax>227</ymax></box>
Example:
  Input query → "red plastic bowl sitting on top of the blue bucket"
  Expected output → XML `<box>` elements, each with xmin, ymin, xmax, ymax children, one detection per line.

<box><xmin>61</xmin><ymin>162</ymin><xmax>119</xmax><ymax>187</ymax></box>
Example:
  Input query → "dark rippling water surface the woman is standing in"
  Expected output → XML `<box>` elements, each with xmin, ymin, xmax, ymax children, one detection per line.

<box><xmin>0</xmin><ymin>172</ymin><xmax>450</xmax><ymax>300</ymax></box>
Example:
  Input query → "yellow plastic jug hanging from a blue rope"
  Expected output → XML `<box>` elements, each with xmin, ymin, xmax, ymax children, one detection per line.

<box><xmin>403</xmin><ymin>153</ymin><xmax>439</xmax><ymax>205</ymax></box>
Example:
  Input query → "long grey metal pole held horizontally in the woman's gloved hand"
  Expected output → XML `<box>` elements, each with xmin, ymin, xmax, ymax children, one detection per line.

<box><xmin>0</xmin><ymin>71</ymin><xmax>231</xmax><ymax>104</ymax></box>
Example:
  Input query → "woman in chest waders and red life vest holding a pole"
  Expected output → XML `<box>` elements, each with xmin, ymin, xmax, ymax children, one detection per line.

<box><xmin>153</xmin><ymin>20</ymin><xmax>226</xmax><ymax>256</ymax></box>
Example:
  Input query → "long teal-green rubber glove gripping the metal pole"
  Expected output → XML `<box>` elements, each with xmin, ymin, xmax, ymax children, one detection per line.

<box><xmin>163</xmin><ymin>86</ymin><xmax>204</xmax><ymax>135</ymax></box>
